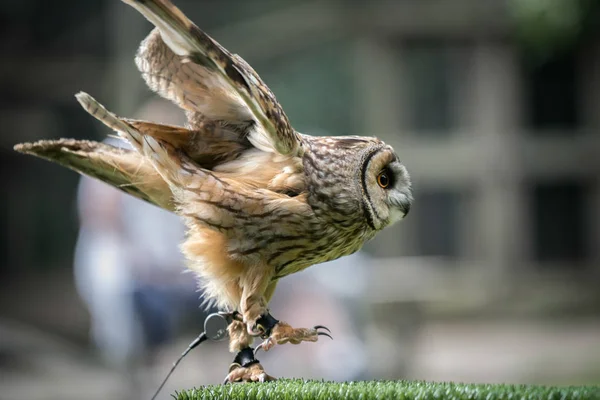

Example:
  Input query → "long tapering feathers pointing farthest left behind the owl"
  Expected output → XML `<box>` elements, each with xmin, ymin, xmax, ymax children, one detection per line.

<box><xmin>15</xmin><ymin>139</ymin><xmax>174</xmax><ymax>211</ymax></box>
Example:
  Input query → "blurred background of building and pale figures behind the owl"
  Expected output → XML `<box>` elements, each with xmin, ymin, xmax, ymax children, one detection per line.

<box><xmin>0</xmin><ymin>0</ymin><xmax>600</xmax><ymax>400</ymax></box>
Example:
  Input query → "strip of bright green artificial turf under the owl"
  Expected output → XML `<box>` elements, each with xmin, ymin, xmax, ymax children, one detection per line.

<box><xmin>176</xmin><ymin>379</ymin><xmax>600</xmax><ymax>400</ymax></box>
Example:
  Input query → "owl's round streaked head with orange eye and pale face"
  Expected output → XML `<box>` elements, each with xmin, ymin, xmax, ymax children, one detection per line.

<box><xmin>303</xmin><ymin>136</ymin><xmax>413</xmax><ymax>231</ymax></box>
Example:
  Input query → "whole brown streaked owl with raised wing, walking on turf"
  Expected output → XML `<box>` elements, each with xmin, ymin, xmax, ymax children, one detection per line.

<box><xmin>15</xmin><ymin>0</ymin><xmax>412</xmax><ymax>382</ymax></box>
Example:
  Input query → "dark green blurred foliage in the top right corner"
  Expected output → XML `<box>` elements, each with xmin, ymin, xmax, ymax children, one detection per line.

<box><xmin>508</xmin><ymin>0</ymin><xmax>600</xmax><ymax>61</ymax></box>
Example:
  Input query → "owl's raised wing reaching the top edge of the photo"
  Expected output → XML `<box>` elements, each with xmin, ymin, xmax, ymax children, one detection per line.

<box><xmin>123</xmin><ymin>0</ymin><xmax>300</xmax><ymax>155</ymax></box>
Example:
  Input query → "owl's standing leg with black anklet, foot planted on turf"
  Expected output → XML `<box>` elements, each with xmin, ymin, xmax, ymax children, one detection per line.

<box><xmin>223</xmin><ymin>319</ymin><xmax>275</xmax><ymax>384</ymax></box>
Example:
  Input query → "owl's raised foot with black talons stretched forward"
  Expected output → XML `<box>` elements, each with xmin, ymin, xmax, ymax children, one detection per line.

<box><xmin>254</xmin><ymin>314</ymin><xmax>333</xmax><ymax>353</ymax></box>
